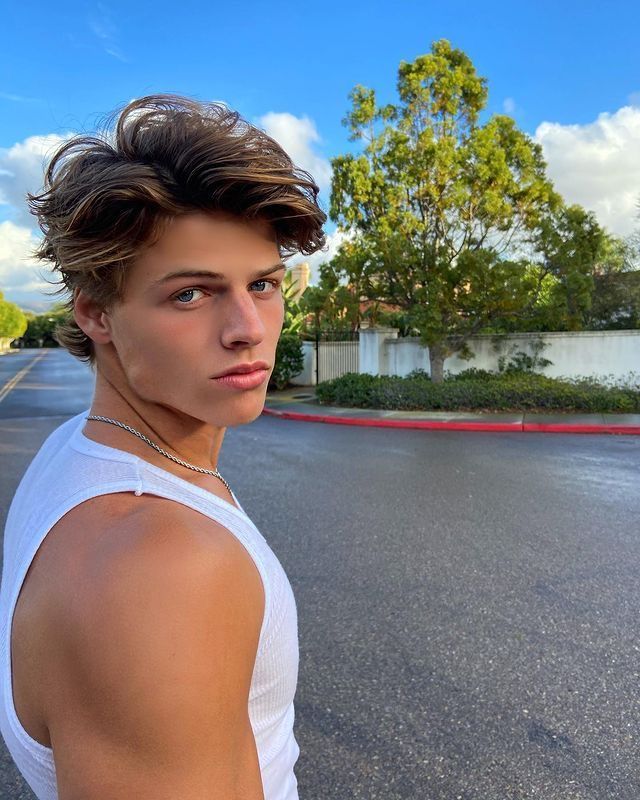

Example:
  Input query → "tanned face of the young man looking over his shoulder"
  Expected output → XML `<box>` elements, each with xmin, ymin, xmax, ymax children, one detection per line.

<box><xmin>98</xmin><ymin>213</ymin><xmax>284</xmax><ymax>427</ymax></box>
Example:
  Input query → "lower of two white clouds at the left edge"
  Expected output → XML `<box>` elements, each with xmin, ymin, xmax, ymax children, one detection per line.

<box><xmin>0</xmin><ymin>220</ymin><xmax>54</xmax><ymax>306</ymax></box>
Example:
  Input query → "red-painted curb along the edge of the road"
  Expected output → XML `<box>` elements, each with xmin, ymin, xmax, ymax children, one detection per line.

<box><xmin>262</xmin><ymin>408</ymin><xmax>640</xmax><ymax>435</ymax></box>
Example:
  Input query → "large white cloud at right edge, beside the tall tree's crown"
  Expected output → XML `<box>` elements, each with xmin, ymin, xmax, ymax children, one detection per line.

<box><xmin>535</xmin><ymin>106</ymin><xmax>640</xmax><ymax>236</ymax></box>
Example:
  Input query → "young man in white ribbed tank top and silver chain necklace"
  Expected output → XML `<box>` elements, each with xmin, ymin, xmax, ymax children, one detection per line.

<box><xmin>0</xmin><ymin>96</ymin><xmax>325</xmax><ymax>800</ymax></box>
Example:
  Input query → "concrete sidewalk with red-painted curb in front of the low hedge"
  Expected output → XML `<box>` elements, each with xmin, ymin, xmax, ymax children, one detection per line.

<box><xmin>263</xmin><ymin>386</ymin><xmax>640</xmax><ymax>435</ymax></box>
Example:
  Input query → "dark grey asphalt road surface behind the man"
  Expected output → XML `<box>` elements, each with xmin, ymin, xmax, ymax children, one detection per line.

<box><xmin>0</xmin><ymin>351</ymin><xmax>640</xmax><ymax>800</ymax></box>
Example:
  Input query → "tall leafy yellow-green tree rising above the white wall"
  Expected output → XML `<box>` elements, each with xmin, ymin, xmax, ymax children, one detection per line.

<box><xmin>330</xmin><ymin>40</ymin><xmax>561</xmax><ymax>381</ymax></box>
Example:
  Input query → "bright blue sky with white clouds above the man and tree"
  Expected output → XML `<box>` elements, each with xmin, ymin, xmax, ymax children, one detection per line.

<box><xmin>0</xmin><ymin>0</ymin><xmax>640</xmax><ymax>304</ymax></box>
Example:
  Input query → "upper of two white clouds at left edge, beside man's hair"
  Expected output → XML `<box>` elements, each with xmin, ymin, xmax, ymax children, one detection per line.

<box><xmin>0</xmin><ymin>133</ymin><xmax>67</xmax><ymax>227</ymax></box>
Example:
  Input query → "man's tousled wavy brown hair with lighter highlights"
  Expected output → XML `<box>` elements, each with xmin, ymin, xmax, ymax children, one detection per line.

<box><xmin>28</xmin><ymin>95</ymin><xmax>326</xmax><ymax>362</ymax></box>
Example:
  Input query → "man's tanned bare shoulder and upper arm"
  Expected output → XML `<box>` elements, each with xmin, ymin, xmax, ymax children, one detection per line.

<box><xmin>47</xmin><ymin>498</ymin><xmax>264</xmax><ymax>800</ymax></box>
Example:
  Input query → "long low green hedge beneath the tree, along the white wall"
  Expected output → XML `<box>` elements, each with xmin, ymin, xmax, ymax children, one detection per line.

<box><xmin>316</xmin><ymin>369</ymin><xmax>640</xmax><ymax>413</ymax></box>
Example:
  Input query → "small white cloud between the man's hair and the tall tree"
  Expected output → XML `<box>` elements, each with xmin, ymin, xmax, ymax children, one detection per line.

<box><xmin>258</xmin><ymin>111</ymin><xmax>331</xmax><ymax>190</ymax></box>
